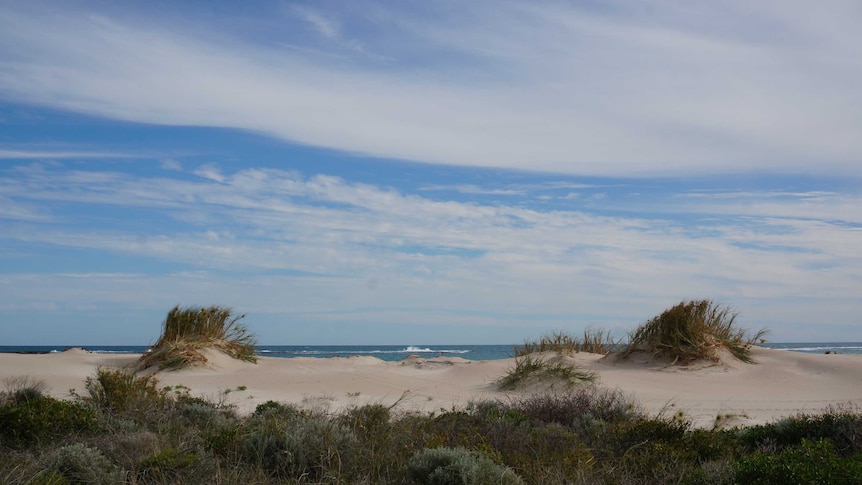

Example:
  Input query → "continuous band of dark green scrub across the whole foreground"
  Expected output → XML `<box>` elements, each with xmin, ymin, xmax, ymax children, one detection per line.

<box><xmin>0</xmin><ymin>370</ymin><xmax>862</xmax><ymax>484</ymax></box>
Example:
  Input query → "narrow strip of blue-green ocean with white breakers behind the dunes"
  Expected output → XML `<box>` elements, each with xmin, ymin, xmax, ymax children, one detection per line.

<box><xmin>0</xmin><ymin>342</ymin><xmax>862</xmax><ymax>361</ymax></box>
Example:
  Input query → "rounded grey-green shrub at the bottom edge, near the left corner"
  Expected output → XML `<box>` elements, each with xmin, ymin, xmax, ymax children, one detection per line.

<box><xmin>37</xmin><ymin>443</ymin><xmax>126</xmax><ymax>485</ymax></box>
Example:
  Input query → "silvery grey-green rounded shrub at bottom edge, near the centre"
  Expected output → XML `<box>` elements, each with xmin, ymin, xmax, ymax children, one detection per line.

<box><xmin>407</xmin><ymin>448</ymin><xmax>523</xmax><ymax>485</ymax></box>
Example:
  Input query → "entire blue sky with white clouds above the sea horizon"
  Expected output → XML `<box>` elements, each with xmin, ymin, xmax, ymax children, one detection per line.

<box><xmin>0</xmin><ymin>0</ymin><xmax>862</xmax><ymax>345</ymax></box>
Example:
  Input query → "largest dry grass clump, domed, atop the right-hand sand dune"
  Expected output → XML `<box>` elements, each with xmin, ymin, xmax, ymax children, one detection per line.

<box><xmin>621</xmin><ymin>300</ymin><xmax>767</xmax><ymax>365</ymax></box>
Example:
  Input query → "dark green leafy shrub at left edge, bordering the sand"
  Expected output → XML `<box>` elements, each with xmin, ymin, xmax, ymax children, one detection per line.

<box><xmin>0</xmin><ymin>396</ymin><xmax>97</xmax><ymax>447</ymax></box>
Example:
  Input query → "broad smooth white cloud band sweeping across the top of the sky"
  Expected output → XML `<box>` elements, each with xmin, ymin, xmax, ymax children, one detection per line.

<box><xmin>0</xmin><ymin>2</ymin><xmax>862</xmax><ymax>176</ymax></box>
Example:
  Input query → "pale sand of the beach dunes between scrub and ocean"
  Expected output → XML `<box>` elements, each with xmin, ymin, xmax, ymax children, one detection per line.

<box><xmin>0</xmin><ymin>348</ymin><xmax>862</xmax><ymax>426</ymax></box>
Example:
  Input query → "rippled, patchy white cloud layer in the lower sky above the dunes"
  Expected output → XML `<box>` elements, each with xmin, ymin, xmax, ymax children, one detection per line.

<box><xmin>0</xmin><ymin>161</ymin><xmax>862</xmax><ymax>338</ymax></box>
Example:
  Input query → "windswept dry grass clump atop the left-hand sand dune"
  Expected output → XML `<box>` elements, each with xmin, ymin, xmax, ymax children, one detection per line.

<box><xmin>140</xmin><ymin>306</ymin><xmax>257</xmax><ymax>369</ymax></box>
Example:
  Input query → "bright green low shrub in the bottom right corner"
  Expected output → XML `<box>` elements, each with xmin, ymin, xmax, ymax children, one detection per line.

<box><xmin>734</xmin><ymin>439</ymin><xmax>862</xmax><ymax>485</ymax></box>
